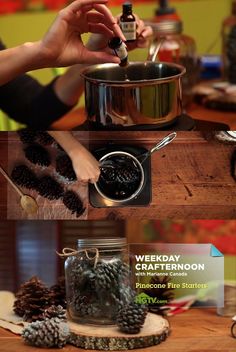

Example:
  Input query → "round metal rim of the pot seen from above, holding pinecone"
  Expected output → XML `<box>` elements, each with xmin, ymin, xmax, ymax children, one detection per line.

<box><xmin>93</xmin><ymin>150</ymin><xmax>144</xmax><ymax>203</ymax></box>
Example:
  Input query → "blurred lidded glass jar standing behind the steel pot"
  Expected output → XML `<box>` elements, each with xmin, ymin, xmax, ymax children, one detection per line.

<box><xmin>147</xmin><ymin>20</ymin><xmax>200</xmax><ymax>107</ymax></box>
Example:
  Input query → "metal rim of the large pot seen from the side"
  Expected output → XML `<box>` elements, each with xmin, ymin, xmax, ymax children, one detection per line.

<box><xmin>80</xmin><ymin>60</ymin><xmax>186</xmax><ymax>87</ymax></box>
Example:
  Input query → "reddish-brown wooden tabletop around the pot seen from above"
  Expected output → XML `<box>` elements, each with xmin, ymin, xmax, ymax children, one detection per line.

<box><xmin>0</xmin><ymin>132</ymin><xmax>236</xmax><ymax>220</ymax></box>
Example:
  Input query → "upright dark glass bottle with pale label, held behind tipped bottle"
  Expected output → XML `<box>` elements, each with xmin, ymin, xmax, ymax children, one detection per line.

<box><xmin>120</xmin><ymin>2</ymin><xmax>136</xmax><ymax>42</ymax></box>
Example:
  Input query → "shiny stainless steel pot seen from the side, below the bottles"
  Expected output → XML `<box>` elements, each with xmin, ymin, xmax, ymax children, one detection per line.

<box><xmin>82</xmin><ymin>61</ymin><xmax>185</xmax><ymax>127</ymax></box>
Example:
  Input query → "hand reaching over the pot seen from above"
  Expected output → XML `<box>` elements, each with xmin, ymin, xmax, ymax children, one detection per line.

<box><xmin>69</xmin><ymin>144</ymin><xmax>100</xmax><ymax>183</ymax></box>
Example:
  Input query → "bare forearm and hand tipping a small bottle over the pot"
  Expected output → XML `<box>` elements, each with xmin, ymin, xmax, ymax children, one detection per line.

<box><xmin>0</xmin><ymin>0</ymin><xmax>125</xmax><ymax>85</ymax></box>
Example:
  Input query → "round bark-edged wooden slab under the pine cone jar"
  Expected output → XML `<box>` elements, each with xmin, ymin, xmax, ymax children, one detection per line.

<box><xmin>69</xmin><ymin>313</ymin><xmax>169</xmax><ymax>351</ymax></box>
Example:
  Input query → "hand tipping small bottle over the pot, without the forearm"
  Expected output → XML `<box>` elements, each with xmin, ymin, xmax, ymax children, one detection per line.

<box><xmin>40</xmin><ymin>0</ymin><xmax>125</xmax><ymax>67</ymax></box>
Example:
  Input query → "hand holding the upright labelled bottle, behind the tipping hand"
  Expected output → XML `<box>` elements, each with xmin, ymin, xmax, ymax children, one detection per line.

<box><xmin>86</xmin><ymin>14</ymin><xmax>153</xmax><ymax>52</ymax></box>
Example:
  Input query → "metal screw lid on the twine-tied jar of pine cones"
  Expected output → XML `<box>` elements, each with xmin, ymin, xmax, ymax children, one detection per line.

<box><xmin>78</xmin><ymin>237</ymin><xmax>127</xmax><ymax>249</ymax></box>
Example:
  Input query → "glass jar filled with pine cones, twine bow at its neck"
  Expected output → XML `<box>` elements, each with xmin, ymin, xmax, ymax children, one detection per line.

<box><xmin>65</xmin><ymin>237</ymin><xmax>132</xmax><ymax>324</ymax></box>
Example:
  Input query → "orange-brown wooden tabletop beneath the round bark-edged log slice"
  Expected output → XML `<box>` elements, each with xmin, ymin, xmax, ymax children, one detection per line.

<box><xmin>0</xmin><ymin>309</ymin><xmax>236</xmax><ymax>352</ymax></box>
